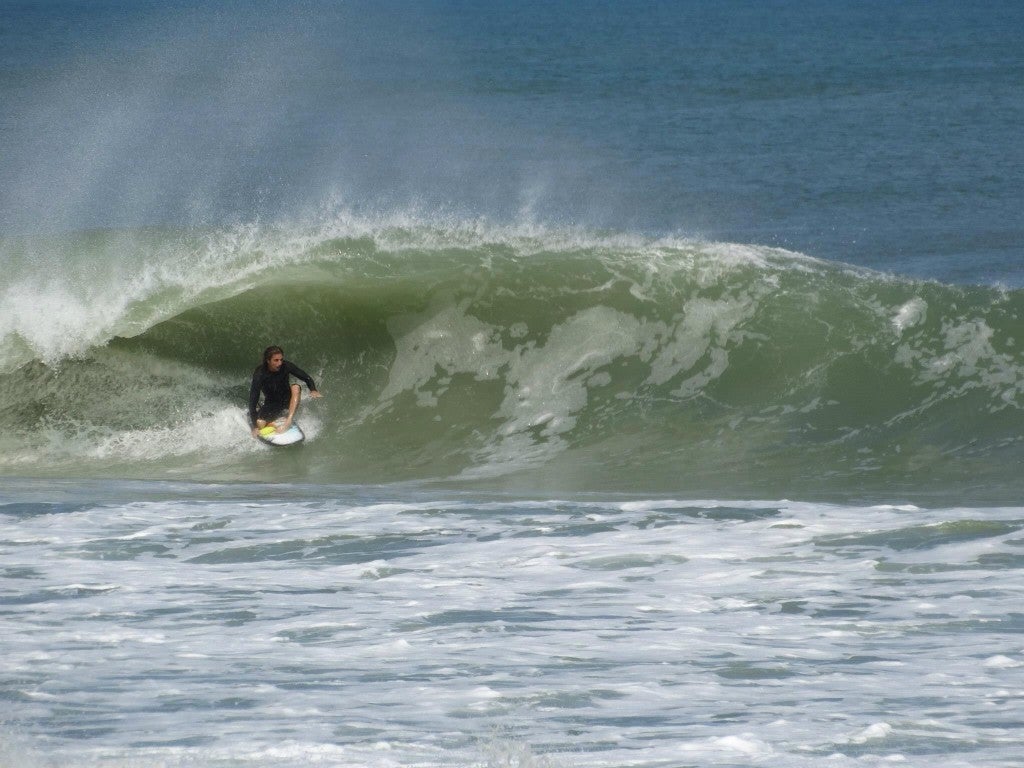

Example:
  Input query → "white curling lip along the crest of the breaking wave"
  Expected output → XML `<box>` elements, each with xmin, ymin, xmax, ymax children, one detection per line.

<box><xmin>0</xmin><ymin>210</ymin><xmax>810</xmax><ymax>365</ymax></box>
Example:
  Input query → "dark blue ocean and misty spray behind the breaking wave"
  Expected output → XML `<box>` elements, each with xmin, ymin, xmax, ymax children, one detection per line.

<box><xmin>0</xmin><ymin>0</ymin><xmax>1024</xmax><ymax>286</ymax></box>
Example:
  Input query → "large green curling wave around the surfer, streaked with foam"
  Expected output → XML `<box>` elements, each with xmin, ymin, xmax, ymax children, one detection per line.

<box><xmin>0</xmin><ymin>221</ymin><xmax>1024</xmax><ymax>501</ymax></box>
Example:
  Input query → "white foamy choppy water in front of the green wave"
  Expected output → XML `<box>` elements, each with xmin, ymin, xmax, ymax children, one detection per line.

<box><xmin>6</xmin><ymin>483</ymin><xmax>1024</xmax><ymax>767</ymax></box>
